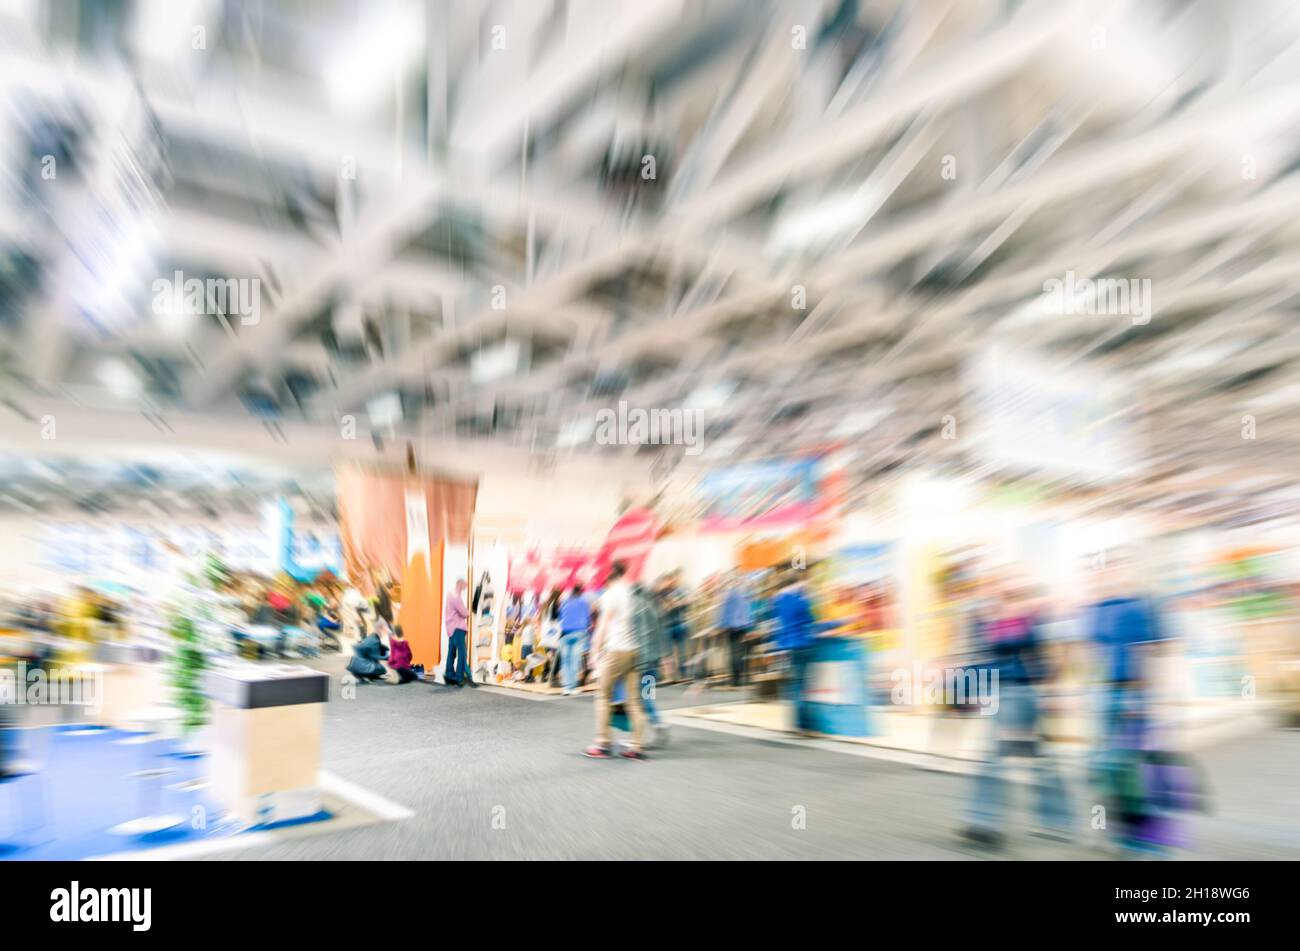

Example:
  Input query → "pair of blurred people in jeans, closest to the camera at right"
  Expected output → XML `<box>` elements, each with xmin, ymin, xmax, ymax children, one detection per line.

<box><xmin>925</xmin><ymin>550</ymin><xmax>1279</xmax><ymax>855</ymax></box>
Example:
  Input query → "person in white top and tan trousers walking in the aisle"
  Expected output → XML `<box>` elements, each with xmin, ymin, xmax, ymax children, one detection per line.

<box><xmin>584</xmin><ymin>561</ymin><xmax>646</xmax><ymax>760</ymax></box>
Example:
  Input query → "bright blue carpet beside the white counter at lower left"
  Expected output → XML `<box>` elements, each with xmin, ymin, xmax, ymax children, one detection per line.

<box><xmin>0</xmin><ymin>726</ymin><xmax>329</xmax><ymax>860</ymax></box>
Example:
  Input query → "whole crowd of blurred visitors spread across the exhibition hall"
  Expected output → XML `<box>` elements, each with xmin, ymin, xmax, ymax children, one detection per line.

<box><xmin>9</xmin><ymin>543</ymin><xmax>1296</xmax><ymax>851</ymax></box>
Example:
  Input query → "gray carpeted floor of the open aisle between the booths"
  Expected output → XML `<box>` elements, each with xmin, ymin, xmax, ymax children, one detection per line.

<box><xmin>200</xmin><ymin>659</ymin><xmax>1300</xmax><ymax>859</ymax></box>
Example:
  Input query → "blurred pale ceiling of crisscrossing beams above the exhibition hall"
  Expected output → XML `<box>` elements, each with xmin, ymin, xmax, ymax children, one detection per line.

<box><xmin>0</xmin><ymin>0</ymin><xmax>1300</xmax><ymax>519</ymax></box>
